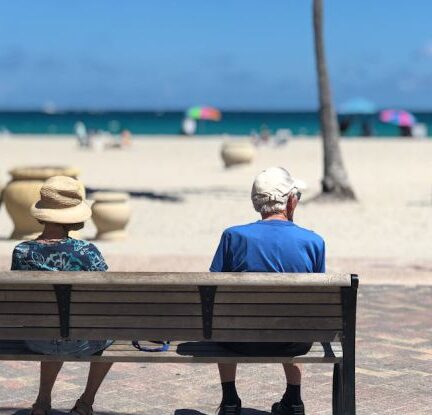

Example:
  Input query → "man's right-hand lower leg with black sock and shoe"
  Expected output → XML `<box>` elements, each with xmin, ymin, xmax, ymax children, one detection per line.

<box><xmin>272</xmin><ymin>364</ymin><xmax>304</xmax><ymax>415</ymax></box>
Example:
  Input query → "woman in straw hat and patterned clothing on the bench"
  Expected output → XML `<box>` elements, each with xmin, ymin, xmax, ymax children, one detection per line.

<box><xmin>11</xmin><ymin>176</ymin><xmax>111</xmax><ymax>415</ymax></box>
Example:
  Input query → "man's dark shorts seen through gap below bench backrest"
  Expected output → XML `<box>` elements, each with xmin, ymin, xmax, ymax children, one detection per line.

<box><xmin>218</xmin><ymin>342</ymin><xmax>312</xmax><ymax>356</ymax></box>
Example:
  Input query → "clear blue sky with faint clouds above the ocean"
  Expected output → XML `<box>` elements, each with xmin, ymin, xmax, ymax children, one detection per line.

<box><xmin>0</xmin><ymin>0</ymin><xmax>432</xmax><ymax>110</ymax></box>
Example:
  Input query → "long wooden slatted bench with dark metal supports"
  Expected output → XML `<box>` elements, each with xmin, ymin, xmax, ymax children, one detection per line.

<box><xmin>0</xmin><ymin>271</ymin><xmax>358</xmax><ymax>415</ymax></box>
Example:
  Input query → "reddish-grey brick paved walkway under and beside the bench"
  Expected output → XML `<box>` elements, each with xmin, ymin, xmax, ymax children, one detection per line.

<box><xmin>0</xmin><ymin>286</ymin><xmax>432</xmax><ymax>415</ymax></box>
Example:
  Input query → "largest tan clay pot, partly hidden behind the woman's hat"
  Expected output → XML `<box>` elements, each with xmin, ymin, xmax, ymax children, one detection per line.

<box><xmin>3</xmin><ymin>167</ymin><xmax>79</xmax><ymax>239</ymax></box>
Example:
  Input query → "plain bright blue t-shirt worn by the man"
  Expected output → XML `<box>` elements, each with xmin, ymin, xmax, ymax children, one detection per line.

<box><xmin>210</xmin><ymin>220</ymin><xmax>325</xmax><ymax>272</ymax></box>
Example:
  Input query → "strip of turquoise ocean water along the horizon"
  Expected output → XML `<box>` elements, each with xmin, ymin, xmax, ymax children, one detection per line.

<box><xmin>0</xmin><ymin>111</ymin><xmax>432</xmax><ymax>137</ymax></box>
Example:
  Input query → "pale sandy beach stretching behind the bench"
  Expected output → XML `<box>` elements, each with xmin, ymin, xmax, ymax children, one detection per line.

<box><xmin>0</xmin><ymin>137</ymin><xmax>432</xmax><ymax>283</ymax></box>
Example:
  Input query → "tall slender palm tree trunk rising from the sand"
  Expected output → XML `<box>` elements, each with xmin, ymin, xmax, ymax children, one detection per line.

<box><xmin>313</xmin><ymin>0</ymin><xmax>355</xmax><ymax>199</ymax></box>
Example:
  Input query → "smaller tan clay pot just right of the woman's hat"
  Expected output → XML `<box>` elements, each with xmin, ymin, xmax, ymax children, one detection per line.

<box><xmin>92</xmin><ymin>192</ymin><xmax>131</xmax><ymax>241</ymax></box>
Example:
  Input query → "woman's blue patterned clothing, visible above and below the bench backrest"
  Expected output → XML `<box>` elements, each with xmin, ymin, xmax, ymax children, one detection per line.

<box><xmin>11</xmin><ymin>238</ymin><xmax>112</xmax><ymax>356</ymax></box>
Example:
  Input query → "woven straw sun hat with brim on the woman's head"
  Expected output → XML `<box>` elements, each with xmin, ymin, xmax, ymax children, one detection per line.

<box><xmin>30</xmin><ymin>176</ymin><xmax>91</xmax><ymax>224</ymax></box>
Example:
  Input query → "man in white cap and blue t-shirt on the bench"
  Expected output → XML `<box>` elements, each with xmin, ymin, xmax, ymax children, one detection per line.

<box><xmin>210</xmin><ymin>167</ymin><xmax>325</xmax><ymax>415</ymax></box>
